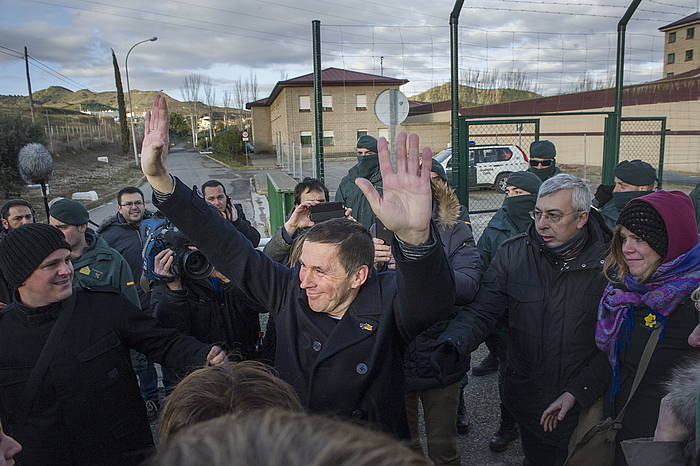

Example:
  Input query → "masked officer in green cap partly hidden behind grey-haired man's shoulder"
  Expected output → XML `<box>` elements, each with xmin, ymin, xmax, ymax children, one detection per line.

<box><xmin>472</xmin><ymin>171</ymin><xmax>542</xmax><ymax>452</ymax></box>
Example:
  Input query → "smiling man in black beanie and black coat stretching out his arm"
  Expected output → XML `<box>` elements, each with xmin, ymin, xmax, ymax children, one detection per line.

<box><xmin>0</xmin><ymin>224</ymin><xmax>225</xmax><ymax>466</ymax></box>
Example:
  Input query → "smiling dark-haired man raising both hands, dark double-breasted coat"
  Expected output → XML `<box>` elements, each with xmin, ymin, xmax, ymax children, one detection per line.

<box><xmin>141</xmin><ymin>96</ymin><xmax>455</xmax><ymax>438</ymax></box>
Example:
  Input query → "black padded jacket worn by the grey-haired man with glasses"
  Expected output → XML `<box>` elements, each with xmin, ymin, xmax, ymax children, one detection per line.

<box><xmin>456</xmin><ymin>210</ymin><xmax>610</xmax><ymax>448</ymax></box>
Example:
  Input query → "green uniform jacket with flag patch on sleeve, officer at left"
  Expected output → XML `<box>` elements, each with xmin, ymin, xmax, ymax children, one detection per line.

<box><xmin>73</xmin><ymin>228</ymin><xmax>141</xmax><ymax>309</ymax></box>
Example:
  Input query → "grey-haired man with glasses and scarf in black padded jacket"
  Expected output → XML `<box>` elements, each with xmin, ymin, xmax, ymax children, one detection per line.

<box><xmin>452</xmin><ymin>174</ymin><xmax>610</xmax><ymax>466</ymax></box>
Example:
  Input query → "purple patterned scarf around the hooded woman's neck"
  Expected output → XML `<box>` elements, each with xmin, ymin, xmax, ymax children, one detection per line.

<box><xmin>595</xmin><ymin>238</ymin><xmax>700</xmax><ymax>396</ymax></box>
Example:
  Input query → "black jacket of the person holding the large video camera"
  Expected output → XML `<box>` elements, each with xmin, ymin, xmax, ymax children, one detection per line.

<box><xmin>151</xmin><ymin>278</ymin><xmax>265</xmax><ymax>359</ymax></box>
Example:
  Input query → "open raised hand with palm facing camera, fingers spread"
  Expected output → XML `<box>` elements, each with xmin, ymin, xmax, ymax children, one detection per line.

<box><xmin>355</xmin><ymin>133</ymin><xmax>433</xmax><ymax>245</ymax></box>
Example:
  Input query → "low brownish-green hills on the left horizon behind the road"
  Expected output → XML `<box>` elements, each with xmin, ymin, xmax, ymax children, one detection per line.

<box><xmin>0</xmin><ymin>86</ymin><xmax>247</xmax><ymax>118</ymax></box>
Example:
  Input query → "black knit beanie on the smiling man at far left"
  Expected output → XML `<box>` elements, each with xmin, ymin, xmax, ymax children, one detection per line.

<box><xmin>0</xmin><ymin>223</ymin><xmax>70</xmax><ymax>288</ymax></box>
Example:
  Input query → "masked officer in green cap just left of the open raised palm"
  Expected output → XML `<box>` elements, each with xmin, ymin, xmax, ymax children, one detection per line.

<box><xmin>335</xmin><ymin>134</ymin><xmax>382</xmax><ymax>228</ymax></box>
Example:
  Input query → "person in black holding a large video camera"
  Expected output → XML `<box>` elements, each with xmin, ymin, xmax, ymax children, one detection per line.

<box><xmin>151</xmin><ymin>241</ymin><xmax>265</xmax><ymax>359</ymax></box>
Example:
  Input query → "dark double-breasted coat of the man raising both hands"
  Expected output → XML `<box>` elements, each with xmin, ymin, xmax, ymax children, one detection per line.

<box><xmin>154</xmin><ymin>180</ymin><xmax>455</xmax><ymax>438</ymax></box>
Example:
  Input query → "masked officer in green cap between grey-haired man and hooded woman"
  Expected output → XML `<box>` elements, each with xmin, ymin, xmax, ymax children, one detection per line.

<box><xmin>598</xmin><ymin>160</ymin><xmax>656</xmax><ymax>230</ymax></box>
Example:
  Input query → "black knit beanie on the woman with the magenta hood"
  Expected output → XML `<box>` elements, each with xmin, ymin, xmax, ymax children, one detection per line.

<box><xmin>617</xmin><ymin>200</ymin><xmax>668</xmax><ymax>258</ymax></box>
